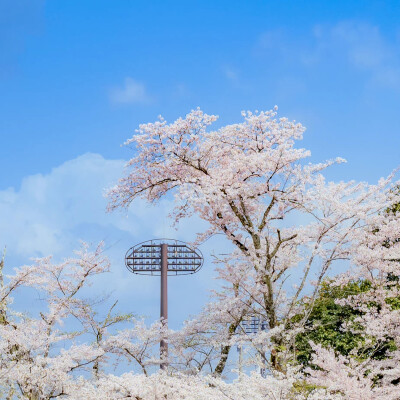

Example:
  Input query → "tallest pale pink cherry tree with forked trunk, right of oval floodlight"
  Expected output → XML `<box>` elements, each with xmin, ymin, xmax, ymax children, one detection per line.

<box><xmin>109</xmin><ymin>109</ymin><xmax>396</xmax><ymax>376</ymax></box>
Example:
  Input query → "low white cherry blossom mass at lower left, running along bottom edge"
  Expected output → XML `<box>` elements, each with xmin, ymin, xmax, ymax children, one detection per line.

<box><xmin>0</xmin><ymin>242</ymin><xmax>338</xmax><ymax>400</ymax></box>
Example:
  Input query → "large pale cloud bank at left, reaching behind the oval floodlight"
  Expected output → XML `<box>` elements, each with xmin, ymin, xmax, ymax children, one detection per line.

<box><xmin>0</xmin><ymin>153</ymin><xmax>224</xmax><ymax>327</ymax></box>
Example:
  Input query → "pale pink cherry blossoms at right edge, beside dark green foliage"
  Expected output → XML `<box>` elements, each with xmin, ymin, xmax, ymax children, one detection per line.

<box><xmin>307</xmin><ymin>198</ymin><xmax>400</xmax><ymax>400</ymax></box>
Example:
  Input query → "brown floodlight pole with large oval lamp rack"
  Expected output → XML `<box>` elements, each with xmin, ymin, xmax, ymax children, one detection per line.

<box><xmin>125</xmin><ymin>239</ymin><xmax>204</xmax><ymax>369</ymax></box>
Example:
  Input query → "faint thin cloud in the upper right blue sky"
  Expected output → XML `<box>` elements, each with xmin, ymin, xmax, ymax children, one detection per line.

<box><xmin>254</xmin><ymin>20</ymin><xmax>400</xmax><ymax>91</ymax></box>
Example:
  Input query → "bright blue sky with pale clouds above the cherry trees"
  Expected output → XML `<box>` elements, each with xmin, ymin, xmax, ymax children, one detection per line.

<box><xmin>0</xmin><ymin>0</ymin><xmax>400</xmax><ymax>327</ymax></box>
